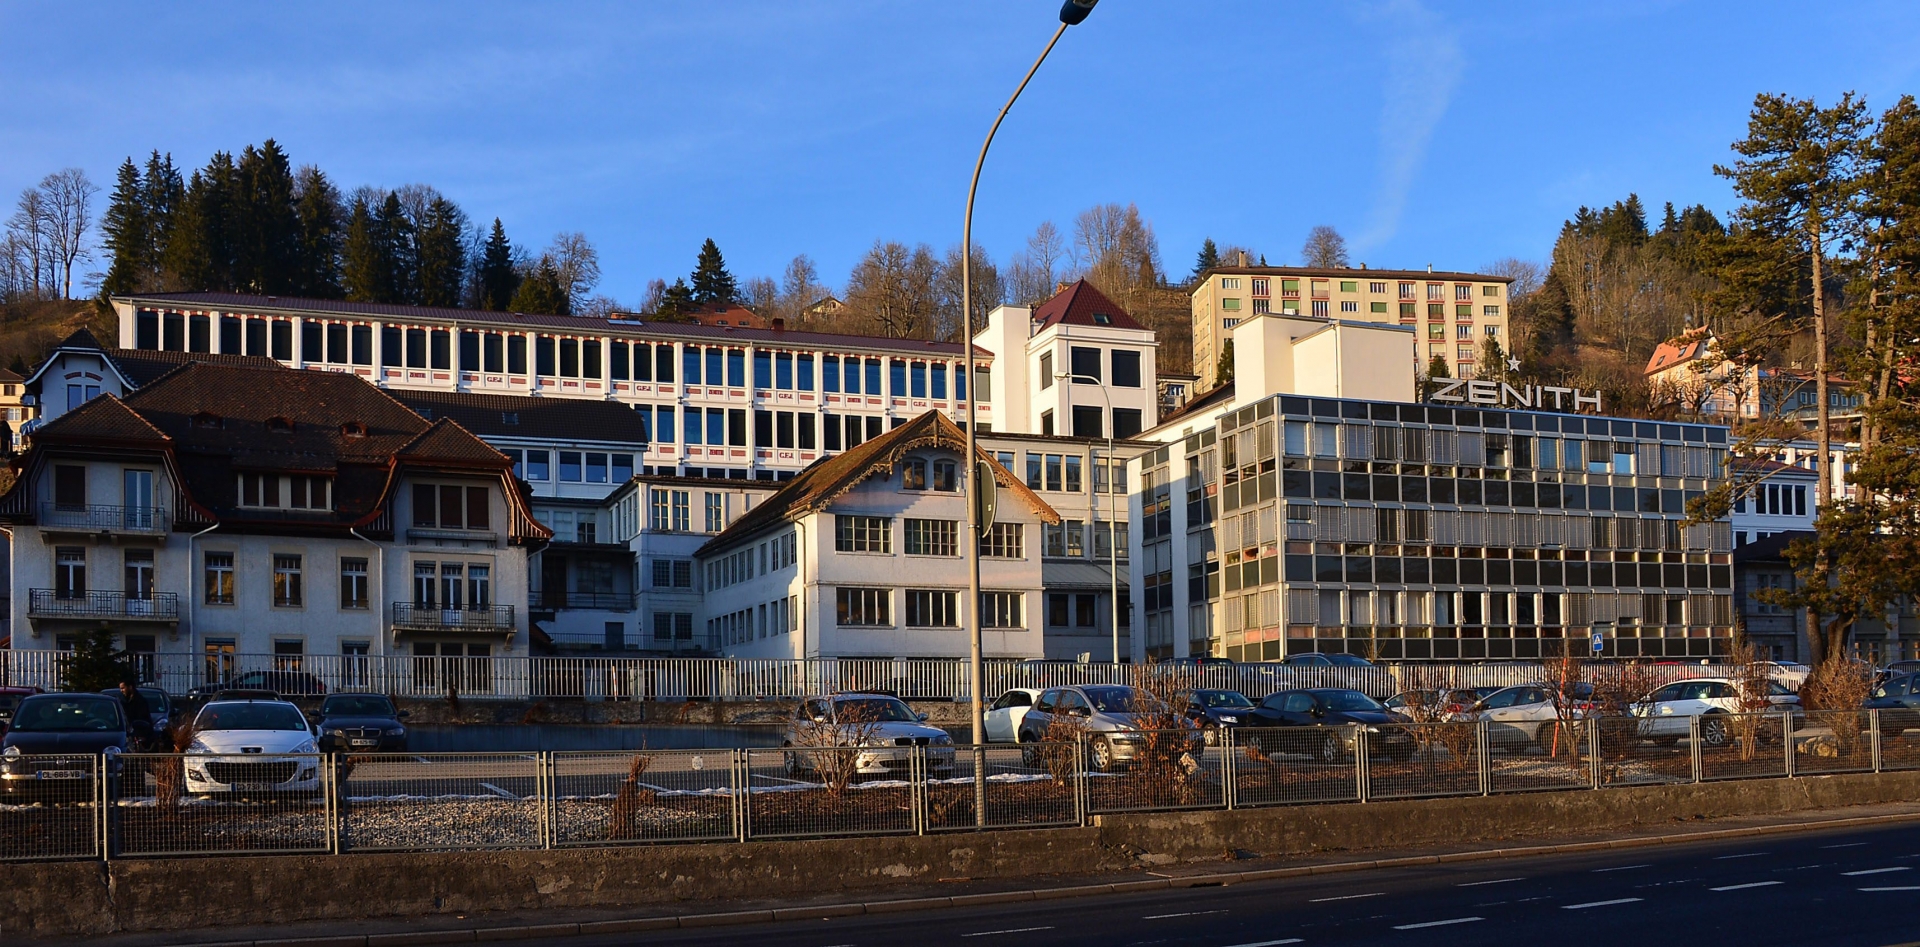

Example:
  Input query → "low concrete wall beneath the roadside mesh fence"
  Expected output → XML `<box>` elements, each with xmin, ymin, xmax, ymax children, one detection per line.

<box><xmin>15</xmin><ymin>772</ymin><xmax>1920</xmax><ymax>937</ymax></box>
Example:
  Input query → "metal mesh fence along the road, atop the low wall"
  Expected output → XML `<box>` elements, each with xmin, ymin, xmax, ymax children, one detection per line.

<box><xmin>0</xmin><ymin>711</ymin><xmax>1920</xmax><ymax>861</ymax></box>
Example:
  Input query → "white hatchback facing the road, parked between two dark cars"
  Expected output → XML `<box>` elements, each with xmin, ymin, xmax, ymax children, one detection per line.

<box><xmin>186</xmin><ymin>701</ymin><xmax>321</xmax><ymax>795</ymax></box>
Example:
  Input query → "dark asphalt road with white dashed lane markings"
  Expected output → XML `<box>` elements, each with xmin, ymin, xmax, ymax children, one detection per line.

<box><xmin>491</xmin><ymin>824</ymin><xmax>1920</xmax><ymax>947</ymax></box>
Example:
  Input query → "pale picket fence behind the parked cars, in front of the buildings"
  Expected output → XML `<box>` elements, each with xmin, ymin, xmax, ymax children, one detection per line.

<box><xmin>0</xmin><ymin>649</ymin><xmax>1751</xmax><ymax>701</ymax></box>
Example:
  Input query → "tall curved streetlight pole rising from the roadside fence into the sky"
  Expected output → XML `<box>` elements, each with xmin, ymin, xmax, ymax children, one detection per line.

<box><xmin>960</xmin><ymin>0</ymin><xmax>1100</xmax><ymax>760</ymax></box>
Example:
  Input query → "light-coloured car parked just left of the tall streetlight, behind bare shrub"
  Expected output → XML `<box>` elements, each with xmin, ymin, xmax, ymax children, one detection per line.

<box><xmin>780</xmin><ymin>693</ymin><xmax>954</xmax><ymax>778</ymax></box>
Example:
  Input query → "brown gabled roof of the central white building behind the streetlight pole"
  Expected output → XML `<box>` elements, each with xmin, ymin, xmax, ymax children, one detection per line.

<box><xmin>695</xmin><ymin>411</ymin><xmax>1060</xmax><ymax>555</ymax></box>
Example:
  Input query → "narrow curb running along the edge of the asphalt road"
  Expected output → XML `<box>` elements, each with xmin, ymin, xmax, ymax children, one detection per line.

<box><xmin>169</xmin><ymin>813</ymin><xmax>1920</xmax><ymax>947</ymax></box>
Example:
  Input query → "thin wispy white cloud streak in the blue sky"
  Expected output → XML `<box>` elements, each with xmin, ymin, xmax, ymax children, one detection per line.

<box><xmin>1354</xmin><ymin>0</ymin><xmax>1465</xmax><ymax>250</ymax></box>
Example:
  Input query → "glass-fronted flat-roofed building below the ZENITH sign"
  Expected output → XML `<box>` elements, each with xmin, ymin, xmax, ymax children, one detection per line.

<box><xmin>1139</xmin><ymin>396</ymin><xmax>1734</xmax><ymax>661</ymax></box>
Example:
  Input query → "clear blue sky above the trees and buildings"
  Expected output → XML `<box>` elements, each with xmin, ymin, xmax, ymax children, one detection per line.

<box><xmin>0</xmin><ymin>0</ymin><xmax>1920</xmax><ymax>302</ymax></box>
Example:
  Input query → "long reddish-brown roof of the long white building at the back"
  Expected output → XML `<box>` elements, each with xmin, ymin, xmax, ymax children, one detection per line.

<box><xmin>115</xmin><ymin>292</ymin><xmax>993</xmax><ymax>357</ymax></box>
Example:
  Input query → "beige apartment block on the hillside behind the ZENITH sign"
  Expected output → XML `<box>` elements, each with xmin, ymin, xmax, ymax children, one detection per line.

<box><xmin>1192</xmin><ymin>267</ymin><xmax>1511</xmax><ymax>390</ymax></box>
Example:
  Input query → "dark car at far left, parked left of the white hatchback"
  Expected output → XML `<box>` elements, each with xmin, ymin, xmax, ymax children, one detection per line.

<box><xmin>0</xmin><ymin>693</ymin><xmax>127</xmax><ymax>803</ymax></box>
